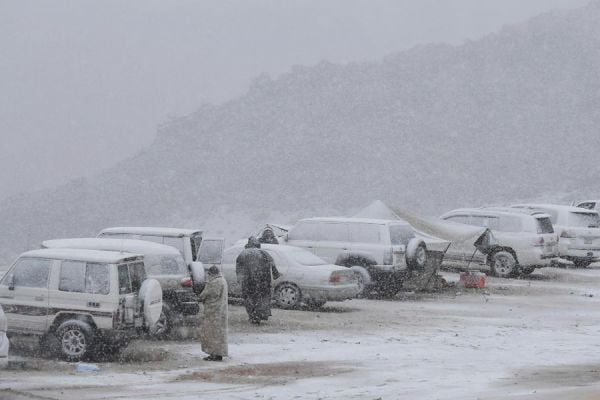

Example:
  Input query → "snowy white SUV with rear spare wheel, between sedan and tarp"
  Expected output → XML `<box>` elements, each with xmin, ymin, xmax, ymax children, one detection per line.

<box><xmin>284</xmin><ymin>217</ymin><xmax>428</xmax><ymax>292</ymax></box>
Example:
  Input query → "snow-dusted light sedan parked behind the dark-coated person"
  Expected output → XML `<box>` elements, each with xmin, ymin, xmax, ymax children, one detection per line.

<box><xmin>221</xmin><ymin>244</ymin><xmax>359</xmax><ymax>308</ymax></box>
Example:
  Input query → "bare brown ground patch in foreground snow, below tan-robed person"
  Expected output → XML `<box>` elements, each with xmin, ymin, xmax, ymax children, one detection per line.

<box><xmin>174</xmin><ymin>361</ymin><xmax>353</xmax><ymax>385</ymax></box>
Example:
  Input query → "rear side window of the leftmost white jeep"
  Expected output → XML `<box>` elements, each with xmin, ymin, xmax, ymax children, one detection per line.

<box><xmin>58</xmin><ymin>260</ymin><xmax>110</xmax><ymax>294</ymax></box>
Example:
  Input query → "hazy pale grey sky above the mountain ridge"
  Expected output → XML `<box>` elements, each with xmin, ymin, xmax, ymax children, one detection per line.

<box><xmin>0</xmin><ymin>0</ymin><xmax>587</xmax><ymax>198</ymax></box>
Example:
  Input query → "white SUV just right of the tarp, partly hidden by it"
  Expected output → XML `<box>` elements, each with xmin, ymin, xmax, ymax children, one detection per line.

<box><xmin>440</xmin><ymin>207</ymin><xmax>558</xmax><ymax>277</ymax></box>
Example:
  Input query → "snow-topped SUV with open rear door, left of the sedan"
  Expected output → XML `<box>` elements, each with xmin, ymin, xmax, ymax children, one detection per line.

<box><xmin>98</xmin><ymin>227</ymin><xmax>224</xmax><ymax>291</ymax></box>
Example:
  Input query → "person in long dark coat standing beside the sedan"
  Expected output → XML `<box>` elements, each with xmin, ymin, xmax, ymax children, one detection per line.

<box><xmin>235</xmin><ymin>236</ymin><xmax>279</xmax><ymax>324</ymax></box>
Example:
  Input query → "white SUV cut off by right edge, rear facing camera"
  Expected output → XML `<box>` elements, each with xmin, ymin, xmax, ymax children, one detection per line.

<box><xmin>512</xmin><ymin>204</ymin><xmax>600</xmax><ymax>267</ymax></box>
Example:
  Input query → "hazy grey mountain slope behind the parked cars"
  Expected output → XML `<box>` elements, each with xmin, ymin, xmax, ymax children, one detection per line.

<box><xmin>0</xmin><ymin>1</ymin><xmax>600</xmax><ymax>258</ymax></box>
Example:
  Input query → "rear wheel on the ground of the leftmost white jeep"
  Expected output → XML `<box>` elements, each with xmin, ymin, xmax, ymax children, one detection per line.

<box><xmin>56</xmin><ymin>320</ymin><xmax>96</xmax><ymax>361</ymax></box>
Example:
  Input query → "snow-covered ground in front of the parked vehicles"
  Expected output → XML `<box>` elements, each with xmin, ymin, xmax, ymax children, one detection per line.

<box><xmin>0</xmin><ymin>268</ymin><xmax>600</xmax><ymax>400</ymax></box>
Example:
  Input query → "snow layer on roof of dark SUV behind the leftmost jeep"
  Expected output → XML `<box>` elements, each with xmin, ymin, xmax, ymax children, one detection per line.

<box><xmin>42</xmin><ymin>238</ymin><xmax>180</xmax><ymax>255</ymax></box>
